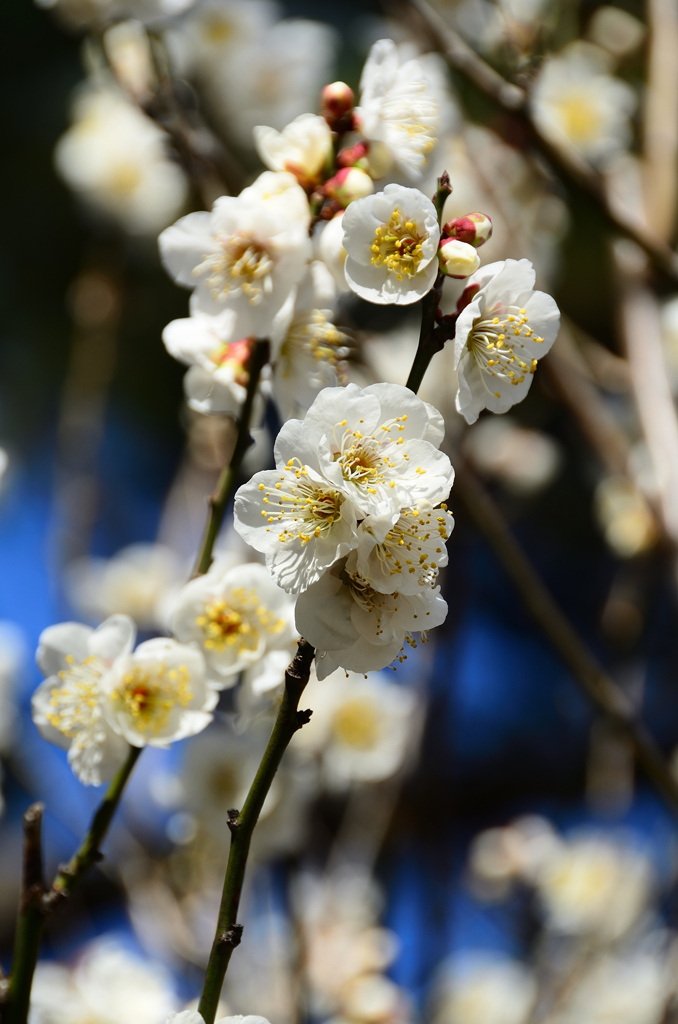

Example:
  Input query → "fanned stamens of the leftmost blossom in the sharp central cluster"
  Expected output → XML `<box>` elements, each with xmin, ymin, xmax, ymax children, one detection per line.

<box><xmin>259</xmin><ymin>468</ymin><xmax>345</xmax><ymax>544</ymax></box>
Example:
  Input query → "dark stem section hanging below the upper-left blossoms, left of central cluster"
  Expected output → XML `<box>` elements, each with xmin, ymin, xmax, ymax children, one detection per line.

<box><xmin>194</xmin><ymin>338</ymin><xmax>270</xmax><ymax>575</ymax></box>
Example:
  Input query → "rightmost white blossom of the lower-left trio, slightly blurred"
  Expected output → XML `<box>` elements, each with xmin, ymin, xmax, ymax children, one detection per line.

<box><xmin>170</xmin><ymin>561</ymin><xmax>296</xmax><ymax>689</ymax></box>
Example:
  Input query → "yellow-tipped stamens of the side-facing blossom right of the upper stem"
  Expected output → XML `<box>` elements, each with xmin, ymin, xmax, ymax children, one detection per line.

<box><xmin>466</xmin><ymin>306</ymin><xmax>544</xmax><ymax>398</ymax></box>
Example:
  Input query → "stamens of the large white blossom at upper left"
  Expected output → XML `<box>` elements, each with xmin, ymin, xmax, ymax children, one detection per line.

<box><xmin>194</xmin><ymin>234</ymin><xmax>274</xmax><ymax>306</ymax></box>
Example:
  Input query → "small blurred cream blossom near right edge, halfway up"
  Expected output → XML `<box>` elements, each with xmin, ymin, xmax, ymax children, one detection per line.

<box><xmin>594</xmin><ymin>476</ymin><xmax>658</xmax><ymax>558</ymax></box>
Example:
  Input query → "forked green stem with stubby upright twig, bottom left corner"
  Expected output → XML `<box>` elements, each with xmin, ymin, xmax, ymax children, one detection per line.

<box><xmin>6</xmin><ymin>746</ymin><xmax>141</xmax><ymax>1024</ymax></box>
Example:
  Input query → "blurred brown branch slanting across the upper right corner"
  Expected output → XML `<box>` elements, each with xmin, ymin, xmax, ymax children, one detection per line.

<box><xmin>389</xmin><ymin>0</ymin><xmax>678</xmax><ymax>282</ymax></box>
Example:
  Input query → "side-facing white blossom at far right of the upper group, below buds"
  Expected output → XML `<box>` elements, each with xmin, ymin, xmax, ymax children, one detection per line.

<box><xmin>455</xmin><ymin>259</ymin><xmax>560</xmax><ymax>423</ymax></box>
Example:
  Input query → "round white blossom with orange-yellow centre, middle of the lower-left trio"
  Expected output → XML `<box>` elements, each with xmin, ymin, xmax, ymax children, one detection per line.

<box><xmin>101</xmin><ymin>637</ymin><xmax>218</xmax><ymax>746</ymax></box>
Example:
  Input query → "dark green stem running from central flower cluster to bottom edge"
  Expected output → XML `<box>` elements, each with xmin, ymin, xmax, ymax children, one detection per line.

<box><xmin>198</xmin><ymin>640</ymin><xmax>315</xmax><ymax>1024</ymax></box>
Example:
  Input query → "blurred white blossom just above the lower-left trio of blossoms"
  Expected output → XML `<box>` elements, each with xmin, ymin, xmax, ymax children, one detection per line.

<box><xmin>66</xmin><ymin>544</ymin><xmax>185</xmax><ymax>630</ymax></box>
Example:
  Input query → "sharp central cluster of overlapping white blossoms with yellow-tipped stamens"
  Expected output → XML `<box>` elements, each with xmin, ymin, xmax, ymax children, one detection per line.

<box><xmin>235</xmin><ymin>384</ymin><xmax>454</xmax><ymax>679</ymax></box>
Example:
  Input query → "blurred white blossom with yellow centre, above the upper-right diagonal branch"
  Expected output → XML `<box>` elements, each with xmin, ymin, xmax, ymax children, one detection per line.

<box><xmin>532</xmin><ymin>43</ymin><xmax>636</xmax><ymax>164</ymax></box>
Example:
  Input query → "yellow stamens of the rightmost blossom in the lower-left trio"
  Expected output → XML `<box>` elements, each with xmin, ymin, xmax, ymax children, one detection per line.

<box><xmin>196</xmin><ymin>587</ymin><xmax>285</xmax><ymax>651</ymax></box>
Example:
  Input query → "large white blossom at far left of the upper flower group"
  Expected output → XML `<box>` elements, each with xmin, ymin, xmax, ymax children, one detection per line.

<box><xmin>159</xmin><ymin>175</ymin><xmax>311</xmax><ymax>337</ymax></box>
